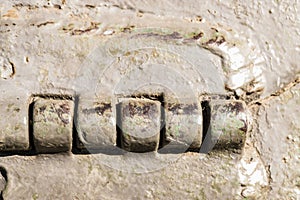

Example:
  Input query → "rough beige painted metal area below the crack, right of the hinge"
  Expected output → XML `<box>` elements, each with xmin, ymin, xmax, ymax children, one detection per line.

<box><xmin>253</xmin><ymin>84</ymin><xmax>300</xmax><ymax>199</ymax></box>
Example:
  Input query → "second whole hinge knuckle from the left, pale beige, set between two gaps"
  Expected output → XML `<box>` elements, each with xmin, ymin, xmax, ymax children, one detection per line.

<box><xmin>74</xmin><ymin>98</ymin><xmax>117</xmax><ymax>150</ymax></box>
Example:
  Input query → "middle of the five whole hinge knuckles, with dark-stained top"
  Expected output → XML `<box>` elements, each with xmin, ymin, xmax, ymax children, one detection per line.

<box><xmin>117</xmin><ymin>98</ymin><xmax>161</xmax><ymax>152</ymax></box>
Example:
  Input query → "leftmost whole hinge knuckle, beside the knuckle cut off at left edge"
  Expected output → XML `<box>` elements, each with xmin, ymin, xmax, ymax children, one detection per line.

<box><xmin>32</xmin><ymin>98</ymin><xmax>74</xmax><ymax>153</ymax></box>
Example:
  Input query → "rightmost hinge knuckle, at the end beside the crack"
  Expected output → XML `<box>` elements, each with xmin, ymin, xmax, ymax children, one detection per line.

<box><xmin>203</xmin><ymin>100</ymin><xmax>248</xmax><ymax>149</ymax></box>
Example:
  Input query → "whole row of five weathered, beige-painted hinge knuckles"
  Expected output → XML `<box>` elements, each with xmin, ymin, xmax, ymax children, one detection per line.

<box><xmin>0</xmin><ymin>97</ymin><xmax>248</xmax><ymax>153</ymax></box>
